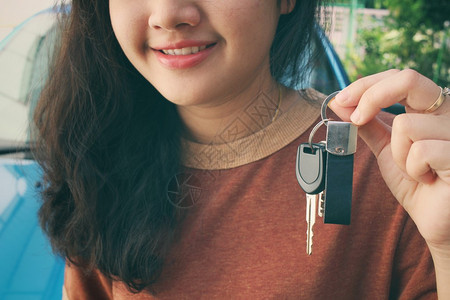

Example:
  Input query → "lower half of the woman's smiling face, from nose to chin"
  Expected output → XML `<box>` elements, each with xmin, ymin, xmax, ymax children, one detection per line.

<box><xmin>109</xmin><ymin>0</ymin><xmax>288</xmax><ymax>106</ymax></box>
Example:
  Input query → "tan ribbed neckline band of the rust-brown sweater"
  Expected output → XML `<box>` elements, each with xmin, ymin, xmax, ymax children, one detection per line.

<box><xmin>181</xmin><ymin>90</ymin><xmax>322</xmax><ymax>170</ymax></box>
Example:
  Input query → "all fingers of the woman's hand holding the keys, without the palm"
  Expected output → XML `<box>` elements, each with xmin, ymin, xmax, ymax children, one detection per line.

<box><xmin>330</xmin><ymin>70</ymin><xmax>450</xmax><ymax>183</ymax></box>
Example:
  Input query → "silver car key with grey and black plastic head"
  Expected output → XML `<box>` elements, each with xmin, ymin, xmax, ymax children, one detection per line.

<box><xmin>296</xmin><ymin>143</ymin><xmax>327</xmax><ymax>255</ymax></box>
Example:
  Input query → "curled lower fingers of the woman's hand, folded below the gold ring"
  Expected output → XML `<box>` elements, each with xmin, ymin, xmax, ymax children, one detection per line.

<box><xmin>391</xmin><ymin>114</ymin><xmax>450</xmax><ymax>183</ymax></box>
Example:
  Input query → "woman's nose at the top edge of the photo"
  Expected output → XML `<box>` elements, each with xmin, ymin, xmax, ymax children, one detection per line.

<box><xmin>148</xmin><ymin>0</ymin><xmax>201</xmax><ymax>31</ymax></box>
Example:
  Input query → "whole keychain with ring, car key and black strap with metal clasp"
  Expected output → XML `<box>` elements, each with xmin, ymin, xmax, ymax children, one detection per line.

<box><xmin>296</xmin><ymin>91</ymin><xmax>358</xmax><ymax>254</ymax></box>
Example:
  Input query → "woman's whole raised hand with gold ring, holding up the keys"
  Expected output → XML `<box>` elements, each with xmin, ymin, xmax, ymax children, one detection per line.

<box><xmin>330</xmin><ymin>70</ymin><xmax>450</xmax><ymax>296</ymax></box>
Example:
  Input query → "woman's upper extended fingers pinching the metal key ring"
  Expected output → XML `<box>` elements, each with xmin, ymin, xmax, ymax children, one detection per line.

<box><xmin>332</xmin><ymin>70</ymin><xmax>449</xmax><ymax>125</ymax></box>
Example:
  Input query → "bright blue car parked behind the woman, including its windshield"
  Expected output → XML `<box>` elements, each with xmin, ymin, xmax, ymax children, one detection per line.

<box><xmin>0</xmin><ymin>5</ymin><xmax>349</xmax><ymax>300</ymax></box>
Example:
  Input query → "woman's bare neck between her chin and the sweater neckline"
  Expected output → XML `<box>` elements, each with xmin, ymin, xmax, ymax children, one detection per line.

<box><xmin>178</xmin><ymin>81</ymin><xmax>286</xmax><ymax>144</ymax></box>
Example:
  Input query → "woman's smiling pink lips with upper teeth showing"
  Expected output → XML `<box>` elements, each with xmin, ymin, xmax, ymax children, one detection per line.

<box><xmin>153</xmin><ymin>42</ymin><xmax>216</xmax><ymax>69</ymax></box>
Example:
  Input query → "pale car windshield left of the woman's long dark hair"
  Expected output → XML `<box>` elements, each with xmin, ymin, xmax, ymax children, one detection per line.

<box><xmin>0</xmin><ymin>13</ymin><xmax>55</xmax><ymax>142</ymax></box>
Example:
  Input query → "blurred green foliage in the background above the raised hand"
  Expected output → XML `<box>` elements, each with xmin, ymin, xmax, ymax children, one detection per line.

<box><xmin>344</xmin><ymin>0</ymin><xmax>450</xmax><ymax>86</ymax></box>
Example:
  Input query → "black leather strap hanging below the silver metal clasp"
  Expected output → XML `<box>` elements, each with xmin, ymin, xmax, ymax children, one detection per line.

<box><xmin>323</xmin><ymin>153</ymin><xmax>353</xmax><ymax>225</ymax></box>
